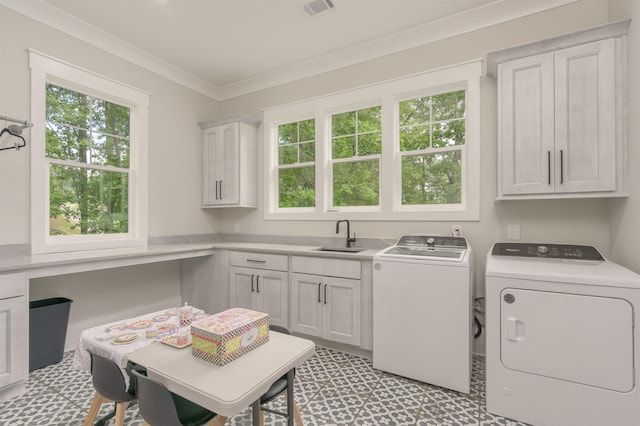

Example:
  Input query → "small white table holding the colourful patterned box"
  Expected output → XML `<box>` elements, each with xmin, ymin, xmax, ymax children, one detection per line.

<box><xmin>128</xmin><ymin>332</ymin><xmax>315</xmax><ymax>426</ymax></box>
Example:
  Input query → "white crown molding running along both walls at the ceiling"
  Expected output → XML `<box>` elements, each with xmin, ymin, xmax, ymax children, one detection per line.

<box><xmin>0</xmin><ymin>0</ymin><xmax>581</xmax><ymax>101</ymax></box>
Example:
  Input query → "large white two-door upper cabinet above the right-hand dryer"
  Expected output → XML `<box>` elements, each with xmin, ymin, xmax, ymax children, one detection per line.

<box><xmin>488</xmin><ymin>21</ymin><xmax>629</xmax><ymax>199</ymax></box>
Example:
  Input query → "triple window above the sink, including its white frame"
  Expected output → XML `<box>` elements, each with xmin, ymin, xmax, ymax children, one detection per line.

<box><xmin>264</xmin><ymin>61</ymin><xmax>481</xmax><ymax>221</ymax></box>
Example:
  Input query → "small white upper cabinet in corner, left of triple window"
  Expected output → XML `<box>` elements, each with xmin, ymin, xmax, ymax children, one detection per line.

<box><xmin>200</xmin><ymin>115</ymin><xmax>259</xmax><ymax>208</ymax></box>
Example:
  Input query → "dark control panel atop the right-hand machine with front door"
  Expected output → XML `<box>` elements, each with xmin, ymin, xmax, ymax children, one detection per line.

<box><xmin>491</xmin><ymin>243</ymin><xmax>604</xmax><ymax>261</ymax></box>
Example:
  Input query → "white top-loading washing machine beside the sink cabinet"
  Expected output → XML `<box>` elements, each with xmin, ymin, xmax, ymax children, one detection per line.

<box><xmin>373</xmin><ymin>235</ymin><xmax>473</xmax><ymax>393</ymax></box>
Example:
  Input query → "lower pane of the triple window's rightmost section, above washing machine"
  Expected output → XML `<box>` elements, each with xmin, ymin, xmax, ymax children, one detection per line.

<box><xmin>402</xmin><ymin>150</ymin><xmax>462</xmax><ymax>205</ymax></box>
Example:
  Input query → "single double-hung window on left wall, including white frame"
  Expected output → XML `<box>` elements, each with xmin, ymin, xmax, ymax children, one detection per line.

<box><xmin>30</xmin><ymin>52</ymin><xmax>148</xmax><ymax>253</ymax></box>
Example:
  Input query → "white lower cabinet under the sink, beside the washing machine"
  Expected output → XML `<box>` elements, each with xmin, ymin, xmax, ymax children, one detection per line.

<box><xmin>291</xmin><ymin>256</ymin><xmax>362</xmax><ymax>346</ymax></box>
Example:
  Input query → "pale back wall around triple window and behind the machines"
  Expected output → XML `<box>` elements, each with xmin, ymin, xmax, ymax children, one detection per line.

<box><xmin>219</xmin><ymin>0</ymin><xmax>610</xmax><ymax>293</ymax></box>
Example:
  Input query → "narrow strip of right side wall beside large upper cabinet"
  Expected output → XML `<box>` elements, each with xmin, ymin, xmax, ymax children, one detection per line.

<box><xmin>609</xmin><ymin>0</ymin><xmax>640</xmax><ymax>272</ymax></box>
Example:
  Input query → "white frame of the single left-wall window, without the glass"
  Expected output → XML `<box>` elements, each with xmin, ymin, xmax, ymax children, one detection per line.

<box><xmin>29</xmin><ymin>50</ymin><xmax>149</xmax><ymax>254</ymax></box>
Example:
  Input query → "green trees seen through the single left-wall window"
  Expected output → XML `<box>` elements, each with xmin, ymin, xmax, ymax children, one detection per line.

<box><xmin>45</xmin><ymin>84</ymin><xmax>131</xmax><ymax>235</ymax></box>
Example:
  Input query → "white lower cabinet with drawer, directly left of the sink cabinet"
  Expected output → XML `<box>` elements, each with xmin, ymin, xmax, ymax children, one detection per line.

<box><xmin>229</xmin><ymin>252</ymin><xmax>289</xmax><ymax>327</ymax></box>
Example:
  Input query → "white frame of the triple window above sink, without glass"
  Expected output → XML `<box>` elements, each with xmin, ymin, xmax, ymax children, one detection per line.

<box><xmin>263</xmin><ymin>60</ymin><xmax>482</xmax><ymax>221</ymax></box>
